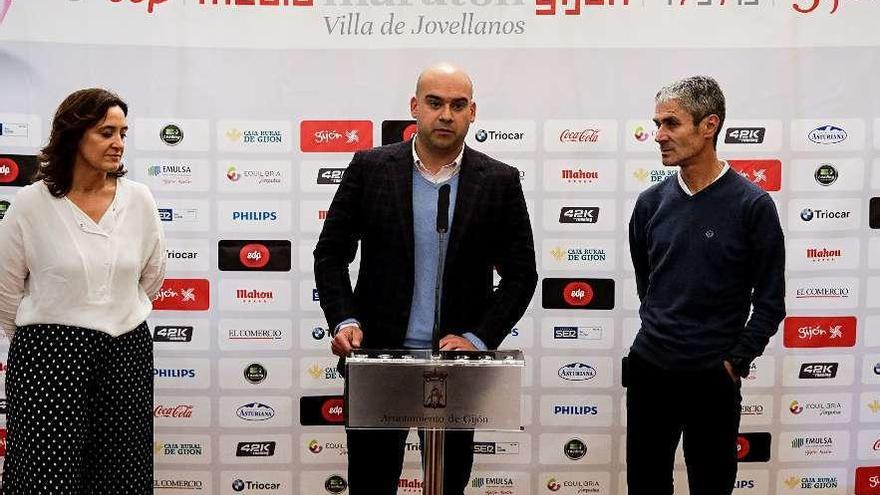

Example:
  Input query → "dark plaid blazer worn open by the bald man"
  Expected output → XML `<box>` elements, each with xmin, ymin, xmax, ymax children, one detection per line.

<box><xmin>314</xmin><ymin>141</ymin><xmax>538</xmax><ymax>349</ymax></box>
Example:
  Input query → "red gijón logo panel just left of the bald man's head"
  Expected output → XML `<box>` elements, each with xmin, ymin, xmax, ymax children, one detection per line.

<box><xmin>299</xmin><ymin>120</ymin><xmax>373</xmax><ymax>153</ymax></box>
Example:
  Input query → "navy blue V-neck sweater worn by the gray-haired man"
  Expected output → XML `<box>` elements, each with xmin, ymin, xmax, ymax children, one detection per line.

<box><xmin>629</xmin><ymin>169</ymin><xmax>785</xmax><ymax>370</ymax></box>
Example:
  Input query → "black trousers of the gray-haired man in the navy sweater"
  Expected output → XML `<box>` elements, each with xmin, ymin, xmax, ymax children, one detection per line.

<box><xmin>624</xmin><ymin>352</ymin><xmax>742</xmax><ymax>495</ymax></box>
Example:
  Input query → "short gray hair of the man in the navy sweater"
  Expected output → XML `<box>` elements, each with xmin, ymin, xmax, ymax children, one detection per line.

<box><xmin>654</xmin><ymin>76</ymin><xmax>726</xmax><ymax>146</ymax></box>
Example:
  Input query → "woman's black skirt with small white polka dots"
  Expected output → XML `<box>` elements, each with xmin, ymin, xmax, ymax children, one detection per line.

<box><xmin>0</xmin><ymin>323</ymin><xmax>153</xmax><ymax>495</ymax></box>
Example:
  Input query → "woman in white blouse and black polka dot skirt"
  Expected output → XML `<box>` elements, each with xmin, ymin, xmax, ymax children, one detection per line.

<box><xmin>0</xmin><ymin>89</ymin><xmax>165</xmax><ymax>495</ymax></box>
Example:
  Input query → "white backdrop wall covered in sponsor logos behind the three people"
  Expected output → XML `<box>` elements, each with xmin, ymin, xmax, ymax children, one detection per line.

<box><xmin>0</xmin><ymin>0</ymin><xmax>880</xmax><ymax>495</ymax></box>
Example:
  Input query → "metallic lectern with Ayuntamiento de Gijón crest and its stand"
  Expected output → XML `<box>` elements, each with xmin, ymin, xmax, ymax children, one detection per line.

<box><xmin>345</xmin><ymin>349</ymin><xmax>525</xmax><ymax>495</ymax></box>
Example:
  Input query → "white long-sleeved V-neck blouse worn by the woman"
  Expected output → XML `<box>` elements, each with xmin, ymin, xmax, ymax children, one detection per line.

<box><xmin>0</xmin><ymin>178</ymin><xmax>165</xmax><ymax>338</ymax></box>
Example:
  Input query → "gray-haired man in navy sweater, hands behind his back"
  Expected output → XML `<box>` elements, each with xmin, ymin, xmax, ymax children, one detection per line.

<box><xmin>623</xmin><ymin>76</ymin><xmax>785</xmax><ymax>495</ymax></box>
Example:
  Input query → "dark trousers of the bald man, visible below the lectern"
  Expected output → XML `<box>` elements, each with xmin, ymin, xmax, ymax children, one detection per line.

<box><xmin>346</xmin><ymin>429</ymin><xmax>474</xmax><ymax>495</ymax></box>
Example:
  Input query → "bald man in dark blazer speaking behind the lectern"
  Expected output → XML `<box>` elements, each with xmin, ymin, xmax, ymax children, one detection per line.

<box><xmin>314</xmin><ymin>64</ymin><xmax>538</xmax><ymax>495</ymax></box>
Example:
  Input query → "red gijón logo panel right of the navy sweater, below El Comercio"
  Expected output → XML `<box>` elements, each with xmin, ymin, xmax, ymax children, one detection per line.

<box><xmin>783</xmin><ymin>316</ymin><xmax>856</xmax><ymax>348</ymax></box>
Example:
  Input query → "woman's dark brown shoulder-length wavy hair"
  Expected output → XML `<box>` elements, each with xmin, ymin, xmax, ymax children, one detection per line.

<box><xmin>34</xmin><ymin>88</ymin><xmax>128</xmax><ymax>198</ymax></box>
